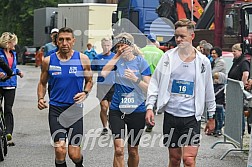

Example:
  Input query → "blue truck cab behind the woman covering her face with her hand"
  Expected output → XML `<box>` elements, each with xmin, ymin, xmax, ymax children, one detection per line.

<box><xmin>112</xmin><ymin>0</ymin><xmax>174</xmax><ymax>47</ymax></box>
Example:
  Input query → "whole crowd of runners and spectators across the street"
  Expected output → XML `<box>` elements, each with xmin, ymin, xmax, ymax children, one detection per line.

<box><xmin>0</xmin><ymin>19</ymin><xmax>252</xmax><ymax>167</ymax></box>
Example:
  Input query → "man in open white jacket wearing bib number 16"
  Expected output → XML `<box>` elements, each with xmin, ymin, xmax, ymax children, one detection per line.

<box><xmin>146</xmin><ymin>19</ymin><xmax>216</xmax><ymax>167</ymax></box>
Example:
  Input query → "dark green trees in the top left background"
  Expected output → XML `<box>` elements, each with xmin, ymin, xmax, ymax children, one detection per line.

<box><xmin>0</xmin><ymin>0</ymin><xmax>82</xmax><ymax>46</ymax></box>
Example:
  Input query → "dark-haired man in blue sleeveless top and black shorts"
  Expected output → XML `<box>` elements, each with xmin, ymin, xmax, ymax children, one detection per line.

<box><xmin>37</xmin><ymin>27</ymin><xmax>93</xmax><ymax>167</ymax></box>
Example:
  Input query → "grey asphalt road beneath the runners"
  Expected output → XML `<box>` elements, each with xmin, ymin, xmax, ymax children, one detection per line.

<box><xmin>0</xmin><ymin>65</ymin><xmax>247</xmax><ymax>167</ymax></box>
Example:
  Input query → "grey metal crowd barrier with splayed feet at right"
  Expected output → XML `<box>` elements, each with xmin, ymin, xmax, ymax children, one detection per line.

<box><xmin>211</xmin><ymin>78</ymin><xmax>248</xmax><ymax>160</ymax></box>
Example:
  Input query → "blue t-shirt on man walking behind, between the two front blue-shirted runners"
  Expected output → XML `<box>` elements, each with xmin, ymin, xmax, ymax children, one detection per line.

<box><xmin>91</xmin><ymin>52</ymin><xmax>115</xmax><ymax>85</ymax></box>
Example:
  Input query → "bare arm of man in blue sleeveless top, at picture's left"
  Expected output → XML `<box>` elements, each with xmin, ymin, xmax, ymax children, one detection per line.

<box><xmin>37</xmin><ymin>56</ymin><xmax>50</xmax><ymax>110</ymax></box>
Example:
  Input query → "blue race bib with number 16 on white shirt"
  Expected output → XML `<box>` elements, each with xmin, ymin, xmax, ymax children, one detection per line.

<box><xmin>171</xmin><ymin>80</ymin><xmax>194</xmax><ymax>96</ymax></box>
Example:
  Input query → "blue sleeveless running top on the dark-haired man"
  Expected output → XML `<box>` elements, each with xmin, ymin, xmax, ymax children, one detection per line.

<box><xmin>48</xmin><ymin>51</ymin><xmax>84</xmax><ymax>106</ymax></box>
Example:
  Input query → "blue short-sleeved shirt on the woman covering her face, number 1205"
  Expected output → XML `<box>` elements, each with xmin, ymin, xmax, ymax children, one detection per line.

<box><xmin>110</xmin><ymin>56</ymin><xmax>151</xmax><ymax>114</ymax></box>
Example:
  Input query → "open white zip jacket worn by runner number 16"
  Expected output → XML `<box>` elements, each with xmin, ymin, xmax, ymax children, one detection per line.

<box><xmin>146</xmin><ymin>47</ymin><xmax>216</xmax><ymax>121</ymax></box>
